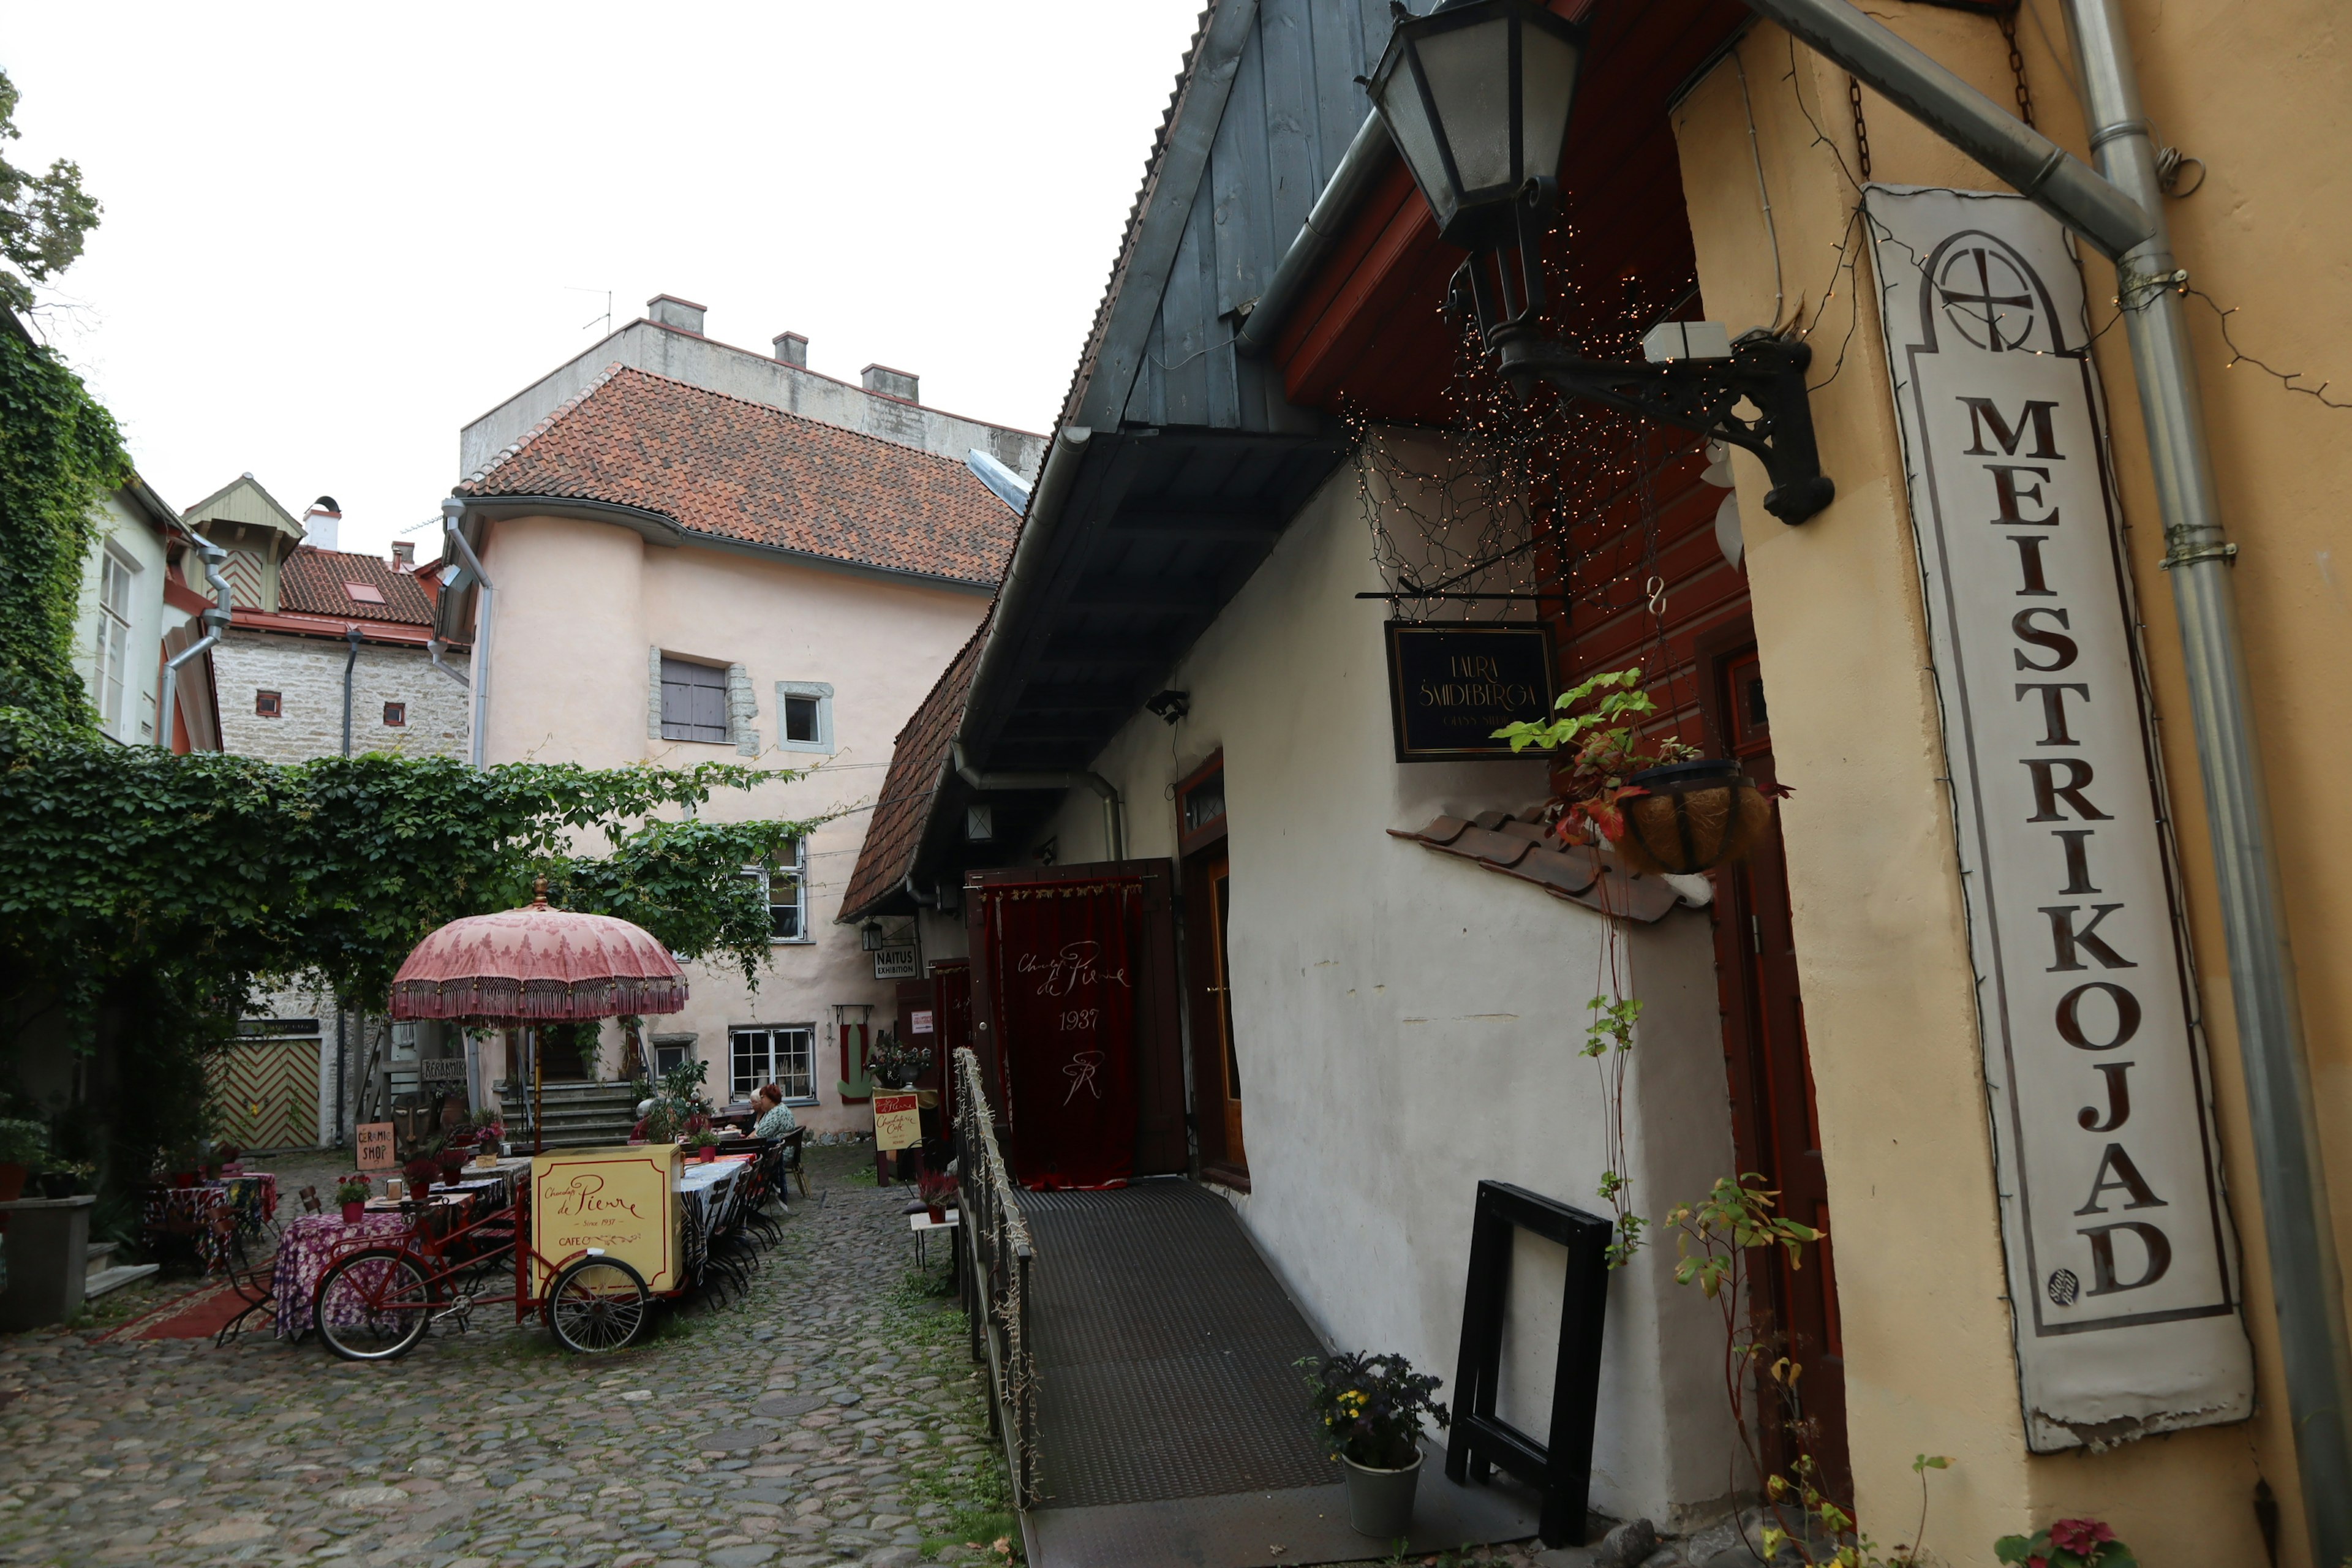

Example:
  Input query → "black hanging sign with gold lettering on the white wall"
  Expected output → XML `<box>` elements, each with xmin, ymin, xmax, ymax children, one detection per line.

<box><xmin>1388</xmin><ymin>620</ymin><xmax>1557</xmax><ymax>762</ymax></box>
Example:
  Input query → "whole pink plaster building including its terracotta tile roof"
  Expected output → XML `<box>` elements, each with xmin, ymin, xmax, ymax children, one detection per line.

<box><xmin>437</xmin><ymin>301</ymin><xmax>1042</xmax><ymax>1138</ymax></box>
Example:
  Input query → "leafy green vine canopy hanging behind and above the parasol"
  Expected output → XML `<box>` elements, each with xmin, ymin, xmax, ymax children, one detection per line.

<box><xmin>0</xmin><ymin>715</ymin><xmax>827</xmax><ymax>1180</ymax></box>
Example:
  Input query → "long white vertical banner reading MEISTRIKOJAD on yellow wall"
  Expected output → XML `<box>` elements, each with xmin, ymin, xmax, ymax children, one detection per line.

<box><xmin>1868</xmin><ymin>186</ymin><xmax>2253</xmax><ymax>1453</ymax></box>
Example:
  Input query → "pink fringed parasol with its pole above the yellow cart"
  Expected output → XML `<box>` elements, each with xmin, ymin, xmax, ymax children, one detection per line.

<box><xmin>393</xmin><ymin>877</ymin><xmax>687</xmax><ymax>1147</ymax></box>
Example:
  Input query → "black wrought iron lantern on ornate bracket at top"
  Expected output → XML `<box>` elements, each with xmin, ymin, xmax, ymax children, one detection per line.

<box><xmin>1366</xmin><ymin>0</ymin><xmax>1837</xmax><ymax>524</ymax></box>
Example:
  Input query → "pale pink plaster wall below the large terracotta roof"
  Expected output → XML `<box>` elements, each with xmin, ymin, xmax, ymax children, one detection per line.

<box><xmin>482</xmin><ymin>517</ymin><xmax>988</xmax><ymax>1133</ymax></box>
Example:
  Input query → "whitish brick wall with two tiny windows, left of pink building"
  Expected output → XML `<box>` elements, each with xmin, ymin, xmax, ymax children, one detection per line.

<box><xmin>212</xmin><ymin>632</ymin><xmax>466</xmax><ymax>762</ymax></box>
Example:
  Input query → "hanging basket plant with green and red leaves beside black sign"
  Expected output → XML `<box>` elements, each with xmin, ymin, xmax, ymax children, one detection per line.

<box><xmin>1493</xmin><ymin>668</ymin><xmax>1787</xmax><ymax>875</ymax></box>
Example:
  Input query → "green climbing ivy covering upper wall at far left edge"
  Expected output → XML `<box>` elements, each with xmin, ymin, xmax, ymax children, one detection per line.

<box><xmin>0</xmin><ymin>322</ymin><xmax>132</xmax><ymax>731</ymax></box>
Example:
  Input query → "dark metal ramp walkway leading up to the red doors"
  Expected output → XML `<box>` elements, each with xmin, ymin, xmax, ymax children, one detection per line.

<box><xmin>1019</xmin><ymin>1180</ymin><xmax>1536</xmax><ymax>1568</ymax></box>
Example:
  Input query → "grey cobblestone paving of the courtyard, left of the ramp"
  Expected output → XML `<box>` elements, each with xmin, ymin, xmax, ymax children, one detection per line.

<box><xmin>0</xmin><ymin>1150</ymin><xmax>1019</xmax><ymax>1568</ymax></box>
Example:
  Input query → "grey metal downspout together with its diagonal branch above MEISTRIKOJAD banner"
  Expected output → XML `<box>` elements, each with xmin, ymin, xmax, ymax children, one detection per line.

<box><xmin>1747</xmin><ymin>0</ymin><xmax>2352</xmax><ymax>1563</ymax></box>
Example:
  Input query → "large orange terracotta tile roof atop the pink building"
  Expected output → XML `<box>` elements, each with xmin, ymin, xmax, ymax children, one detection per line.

<box><xmin>456</xmin><ymin>364</ymin><xmax>1021</xmax><ymax>588</ymax></box>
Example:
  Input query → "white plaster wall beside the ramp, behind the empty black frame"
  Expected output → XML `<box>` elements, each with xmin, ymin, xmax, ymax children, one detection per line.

<box><xmin>1039</xmin><ymin>470</ymin><xmax>1733</xmax><ymax>1523</ymax></box>
